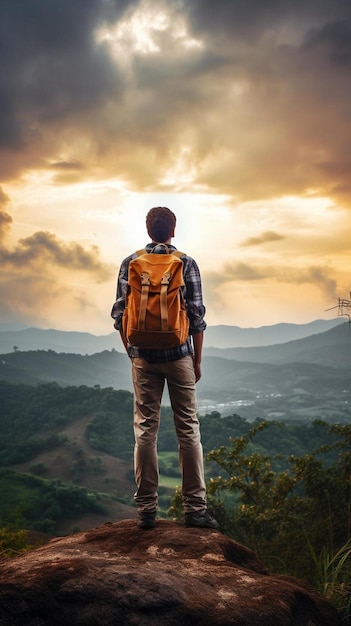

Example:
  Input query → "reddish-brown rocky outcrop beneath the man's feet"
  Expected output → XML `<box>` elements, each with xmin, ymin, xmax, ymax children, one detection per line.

<box><xmin>0</xmin><ymin>520</ymin><xmax>339</xmax><ymax>626</ymax></box>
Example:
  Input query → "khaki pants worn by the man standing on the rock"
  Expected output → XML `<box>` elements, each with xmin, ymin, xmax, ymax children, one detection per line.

<box><xmin>132</xmin><ymin>356</ymin><xmax>206</xmax><ymax>513</ymax></box>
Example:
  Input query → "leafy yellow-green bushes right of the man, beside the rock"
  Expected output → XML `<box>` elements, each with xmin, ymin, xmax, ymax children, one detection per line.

<box><xmin>170</xmin><ymin>420</ymin><xmax>351</xmax><ymax>615</ymax></box>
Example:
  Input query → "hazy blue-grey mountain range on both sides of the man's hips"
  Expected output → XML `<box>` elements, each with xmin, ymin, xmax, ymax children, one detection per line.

<box><xmin>0</xmin><ymin>320</ymin><xmax>351</xmax><ymax>422</ymax></box>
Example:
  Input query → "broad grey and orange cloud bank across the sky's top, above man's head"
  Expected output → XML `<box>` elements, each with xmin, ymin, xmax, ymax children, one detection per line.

<box><xmin>0</xmin><ymin>0</ymin><xmax>351</xmax><ymax>205</ymax></box>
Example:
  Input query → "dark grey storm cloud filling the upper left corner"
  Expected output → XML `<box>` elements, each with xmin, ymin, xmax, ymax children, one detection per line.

<box><xmin>0</xmin><ymin>0</ymin><xmax>138</xmax><ymax>172</ymax></box>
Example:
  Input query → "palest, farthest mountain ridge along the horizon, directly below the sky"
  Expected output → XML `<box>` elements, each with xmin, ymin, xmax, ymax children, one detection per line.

<box><xmin>0</xmin><ymin>318</ymin><xmax>344</xmax><ymax>354</ymax></box>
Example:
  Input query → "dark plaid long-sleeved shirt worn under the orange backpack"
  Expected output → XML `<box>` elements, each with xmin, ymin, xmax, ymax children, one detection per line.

<box><xmin>111</xmin><ymin>243</ymin><xmax>206</xmax><ymax>363</ymax></box>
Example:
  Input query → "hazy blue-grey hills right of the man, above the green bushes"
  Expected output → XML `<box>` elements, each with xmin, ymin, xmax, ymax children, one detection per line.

<box><xmin>198</xmin><ymin>323</ymin><xmax>351</xmax><ymax>423</ymax></box>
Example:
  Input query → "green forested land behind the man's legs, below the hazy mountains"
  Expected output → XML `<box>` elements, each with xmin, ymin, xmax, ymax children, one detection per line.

<box><xmin>0</xmin><ymin>382</ymin><xmax>351</xmax><ymax>615</ymax></box>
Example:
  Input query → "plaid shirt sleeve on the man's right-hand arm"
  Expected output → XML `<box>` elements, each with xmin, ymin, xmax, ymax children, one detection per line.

<box><xmin>182</xmin><ymin>255</ymin><xmax>207</xmax><ymax>335</ymax></box>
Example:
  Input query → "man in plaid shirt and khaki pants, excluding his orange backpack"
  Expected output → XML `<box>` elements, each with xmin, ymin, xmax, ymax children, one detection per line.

<box><xmin>111</xmin><ymin>207</ymin><xmax>218</xmax><ymax>529</ymax></box>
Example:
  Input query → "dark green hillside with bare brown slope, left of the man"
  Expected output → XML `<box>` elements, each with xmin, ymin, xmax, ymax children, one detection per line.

<box><xmin>0</xmin><ymin>383</ymin><xmax>134</xmax><ymax>534</ymax></box>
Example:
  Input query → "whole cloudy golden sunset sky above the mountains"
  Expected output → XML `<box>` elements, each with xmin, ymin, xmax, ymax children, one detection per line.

<box><xmin>0</xmin><ymin>0</ymin><xmax>351</xmax><ymax>334</ymax></box>
